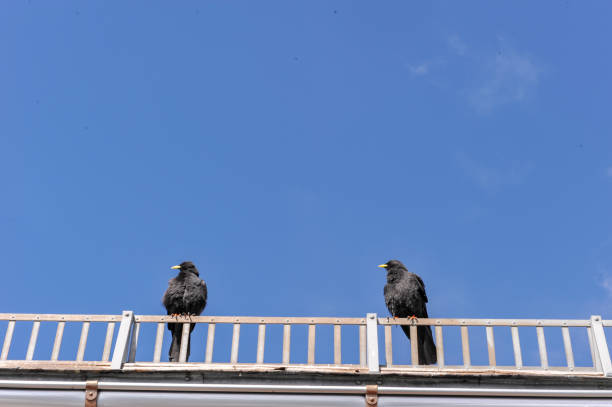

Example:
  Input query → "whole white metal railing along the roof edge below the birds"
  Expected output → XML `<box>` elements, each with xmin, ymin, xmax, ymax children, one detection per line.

<box><xmin>0</xmin><ymin>311</ymin><xmax>612</xmax><ymax>376</ymax></box>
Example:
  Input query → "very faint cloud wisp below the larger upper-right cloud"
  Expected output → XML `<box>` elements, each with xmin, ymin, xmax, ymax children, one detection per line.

<box><xmin>457</xmin><ymin>152</ymin><xmax>531</xmax><ymax>191</ymax></box>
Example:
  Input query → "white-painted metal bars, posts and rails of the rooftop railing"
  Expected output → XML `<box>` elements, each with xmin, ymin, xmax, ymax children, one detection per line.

<box><xmin>0</xmin><ymin>311</ymin><xmax>612</xmax><ymax>375</ymax></box>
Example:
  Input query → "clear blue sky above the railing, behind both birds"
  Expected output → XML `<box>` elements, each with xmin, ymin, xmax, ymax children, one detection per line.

<box><xmin>0</xmin><ymin>0</ymin><xmax>612</xmax><ymax>366</ymax></box>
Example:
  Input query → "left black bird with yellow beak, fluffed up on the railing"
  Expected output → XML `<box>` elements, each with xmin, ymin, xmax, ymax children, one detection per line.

<box><xmin>162</xmin><ymin>261</ymin><xmax>208</xmax><ymax>362</ymax></box>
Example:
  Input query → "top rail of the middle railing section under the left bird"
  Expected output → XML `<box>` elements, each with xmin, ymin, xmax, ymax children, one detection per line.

<box><xmin>134</xmin><ymin>315</ymin><xmax>366</xmax><ymax>325</ymax></box>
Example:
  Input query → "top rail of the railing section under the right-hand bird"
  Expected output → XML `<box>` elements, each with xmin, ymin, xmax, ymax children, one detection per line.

<box><xmin>378</xmin><ymin>317</ymin><xmax>592</xmax><ymax>327</ymax></box>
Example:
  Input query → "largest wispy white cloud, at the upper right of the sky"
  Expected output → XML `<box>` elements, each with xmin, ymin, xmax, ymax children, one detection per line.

<box><xmin>469</xmin><ymin>51</ymin><xmax>540</xmax><ymax>112</ymax></box>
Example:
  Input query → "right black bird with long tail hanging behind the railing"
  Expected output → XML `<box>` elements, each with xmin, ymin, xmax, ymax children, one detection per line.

<box><xmin>378</xmin><ymin>260</ymin><xmax>437</xmax><ymax>365</ymax></box>
